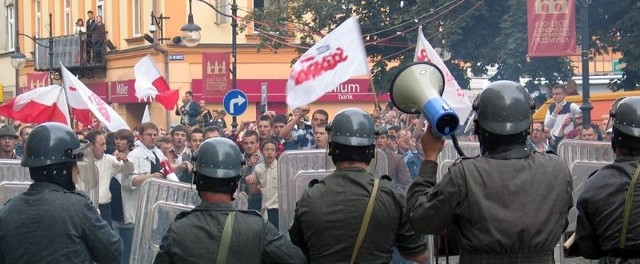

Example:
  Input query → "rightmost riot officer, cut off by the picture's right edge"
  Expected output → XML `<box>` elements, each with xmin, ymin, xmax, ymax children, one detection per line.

<box><xmin>576</xmin><ymin>96</ymin><xmax>640</xmax><ymax>263</ymax></box>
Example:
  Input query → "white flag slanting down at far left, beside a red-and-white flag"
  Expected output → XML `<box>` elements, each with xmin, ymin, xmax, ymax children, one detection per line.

<box><xmin>60</xmin><ymin>63</ymin><xmax>129</xmax><ymax>131</ymax></box>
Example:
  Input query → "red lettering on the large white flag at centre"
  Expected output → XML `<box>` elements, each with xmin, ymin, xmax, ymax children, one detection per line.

<box><xmin>291</xmin><ymin>48</ymin><xmax>349</xmax><ymax>85</ymax></box>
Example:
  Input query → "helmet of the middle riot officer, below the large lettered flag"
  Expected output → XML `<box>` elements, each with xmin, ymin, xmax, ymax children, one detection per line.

<box><xmin>327</xmin><ymin>108</ymin><xmax>376</xmax><ymax>164</ymax></box>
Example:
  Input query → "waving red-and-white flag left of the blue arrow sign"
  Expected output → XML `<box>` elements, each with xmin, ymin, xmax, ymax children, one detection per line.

<box><xmin>133</xmin><ymin>54</ymin><xmax>178</xmax><ymax>110</ymax></box>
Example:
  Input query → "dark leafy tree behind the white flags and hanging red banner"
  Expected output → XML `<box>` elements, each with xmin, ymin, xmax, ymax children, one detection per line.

<box><xmin>246</xmin><ymin>0</ymin><xmax>640</xmax><ymax>93</ymax></box>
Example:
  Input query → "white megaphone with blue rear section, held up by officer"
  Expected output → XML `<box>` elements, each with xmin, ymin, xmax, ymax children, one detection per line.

<box><xmin>389</xmin><ymin>62</ymin><xmax>460</xmax><ymax>137</ymax></box>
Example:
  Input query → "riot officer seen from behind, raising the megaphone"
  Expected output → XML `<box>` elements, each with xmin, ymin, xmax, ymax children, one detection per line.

<box><xmin>408</xmin><ymin>81</ymin><xmax>573</xmax><ymax>263</ymax></box>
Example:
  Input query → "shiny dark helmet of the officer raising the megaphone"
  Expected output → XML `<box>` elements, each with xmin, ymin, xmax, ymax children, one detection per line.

<box><xmin>473</xmin><ymin>81</ymin><xmax>535</xmax><ymax>135</ymax></box>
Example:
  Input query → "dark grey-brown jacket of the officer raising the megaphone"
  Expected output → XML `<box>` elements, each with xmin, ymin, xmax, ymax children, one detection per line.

<box><xmin>408</xmin><ymin>148</ymin><xmax>573</xmax><ymax>263</ymax></box>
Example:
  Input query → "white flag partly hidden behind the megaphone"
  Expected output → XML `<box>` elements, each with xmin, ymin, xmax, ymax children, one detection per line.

<box><xmin>413</xmin><ymin>27</ymin><xmax>471</xmax><ymax>125</ymax></box>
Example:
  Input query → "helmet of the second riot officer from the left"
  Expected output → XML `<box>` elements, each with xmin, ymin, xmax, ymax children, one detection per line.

<box><xmin>193</xmin><ymin>137</ymin><xmax>243</xmax><ymax>195</ymax></box>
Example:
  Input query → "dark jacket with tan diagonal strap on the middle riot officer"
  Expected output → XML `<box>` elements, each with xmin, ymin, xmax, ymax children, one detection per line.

<box><xmin>289</xmin><ymin>168</ymin><xmax>427</xmax><ymax>263</ymax></box>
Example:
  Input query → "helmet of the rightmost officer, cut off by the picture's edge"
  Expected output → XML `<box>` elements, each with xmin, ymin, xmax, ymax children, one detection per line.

<box><xmin>609</xmin><ymin>96</ymin><xmax>640</xmax><ymax>150</ymax></box>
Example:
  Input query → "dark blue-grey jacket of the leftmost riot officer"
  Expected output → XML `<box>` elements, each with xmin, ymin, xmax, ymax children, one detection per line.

<box><xmin>0</xmin><ymin>182</ymin><xmax>122</xmax><ymax>264</ymax></box>
